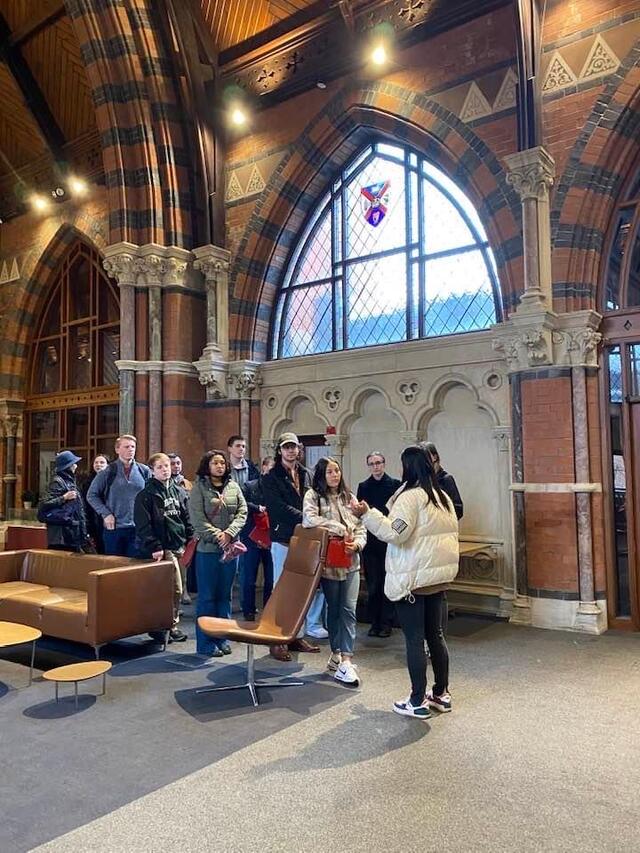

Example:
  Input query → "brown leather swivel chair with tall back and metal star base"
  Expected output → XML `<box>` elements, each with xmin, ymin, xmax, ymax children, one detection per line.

<box><xmin>196</xmin><ymin>524</ymin><xmax>329</xmax><ymax>707</ymax></box>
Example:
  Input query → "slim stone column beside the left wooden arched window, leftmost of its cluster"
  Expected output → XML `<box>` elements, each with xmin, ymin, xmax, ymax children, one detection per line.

<box><xmin>102</xmin><ymin>243</ymin><xmax>138</xmax><ymax>434</ymax></box>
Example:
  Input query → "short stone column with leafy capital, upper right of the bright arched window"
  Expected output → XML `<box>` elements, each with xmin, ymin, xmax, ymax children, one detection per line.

<box><xmin>504</xmin><ymin>146</ymin><xmax>556</xmax><ymax>310</ymax></box>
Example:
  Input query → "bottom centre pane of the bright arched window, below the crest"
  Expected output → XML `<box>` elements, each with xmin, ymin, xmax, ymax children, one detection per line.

<box><xmin>347</xmin><ymin>253</ymin><xmax>407</xmax><ymax>348</ymax></box>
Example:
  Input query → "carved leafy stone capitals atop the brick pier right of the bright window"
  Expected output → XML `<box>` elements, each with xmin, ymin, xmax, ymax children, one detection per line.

<box><xmin>493</xmin><ymin>311</ymin><xmax>602</xmax><ymax>373</ymax></box>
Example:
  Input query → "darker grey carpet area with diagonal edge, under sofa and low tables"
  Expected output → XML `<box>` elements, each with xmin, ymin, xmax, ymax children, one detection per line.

<box><xmin>0</xmin><ymin>608</ymin><xmax>349</xmax><ymax>853</ymax></box>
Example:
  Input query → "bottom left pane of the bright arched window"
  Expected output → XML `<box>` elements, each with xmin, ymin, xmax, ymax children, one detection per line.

<box><xmin>282</xmin><ymin>284</ymin><xmax>332</xmax><ymax>358</ymax></box>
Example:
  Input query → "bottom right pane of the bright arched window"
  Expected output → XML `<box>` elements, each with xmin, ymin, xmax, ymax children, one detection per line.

<box><xmin>424</xmin><ymin>251</ymin><xmax>496</xmax><ymax>337</ymax></box>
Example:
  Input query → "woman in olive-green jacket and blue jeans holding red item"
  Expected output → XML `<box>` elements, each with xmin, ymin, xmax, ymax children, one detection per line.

<box><xmin>189</xmin><ymin>450</ymin><xmax>247</xmax><ymax>661</ymax></box>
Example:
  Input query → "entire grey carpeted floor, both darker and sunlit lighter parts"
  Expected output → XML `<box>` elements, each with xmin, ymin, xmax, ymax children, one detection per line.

<box><xmin>0</xmin><ymin>618</ymin><xmax>640</xmax><ymax>853</ymax></box>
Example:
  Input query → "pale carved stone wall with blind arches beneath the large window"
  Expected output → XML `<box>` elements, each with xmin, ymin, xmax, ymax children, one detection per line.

<box><xmin>260</xmin><ymin>331</ymin><xmax>513</xmax><ymax>600</ymax></box>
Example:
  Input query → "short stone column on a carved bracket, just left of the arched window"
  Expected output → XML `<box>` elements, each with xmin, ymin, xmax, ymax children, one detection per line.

<box><xmin>193</xmin><ymin>246</ymin><xmax>230</xmax><ymax>400</ymax></box>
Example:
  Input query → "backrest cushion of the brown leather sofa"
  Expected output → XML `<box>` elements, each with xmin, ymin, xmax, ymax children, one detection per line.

<box><xmin>20</xmin><ymin>551</ymin><xmax>134</xmax><ymax>592</ymax></box>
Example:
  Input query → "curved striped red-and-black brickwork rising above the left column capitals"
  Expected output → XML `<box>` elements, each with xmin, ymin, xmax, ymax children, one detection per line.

<box><xmin>67</xmin><ymin>0</ymin><xmax>193</xmax><ymax>248</ymax></box>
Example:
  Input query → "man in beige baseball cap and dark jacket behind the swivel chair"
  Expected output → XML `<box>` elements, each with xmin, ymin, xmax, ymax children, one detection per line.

<box><xmin>262</xmin><ymin>432</ymin><xmax>320</xmax><ymax>661</ymax></box>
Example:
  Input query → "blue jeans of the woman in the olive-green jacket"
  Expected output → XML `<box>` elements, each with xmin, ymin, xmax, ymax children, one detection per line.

<box><xmin>195</xmin><ymin>551</ymin><xmax>238</xmax><ymax>655</ymax></box>
